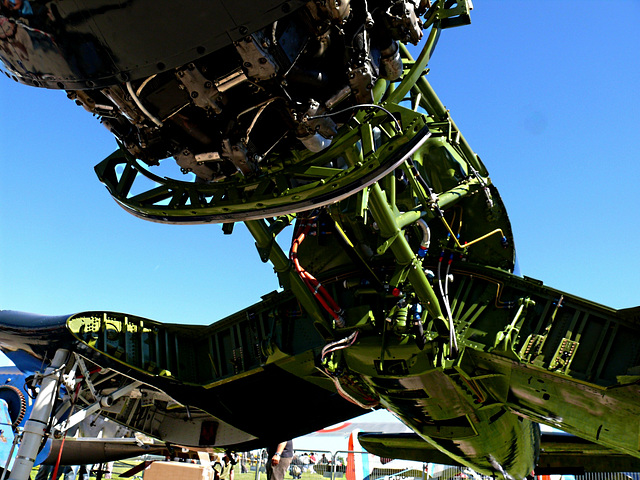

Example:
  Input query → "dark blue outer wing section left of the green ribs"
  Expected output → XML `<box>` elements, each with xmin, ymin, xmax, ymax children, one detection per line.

<box><xmin>0</xmin><ymin>310</ymin><xmax>73</xmax><ymax>374</ymax></box>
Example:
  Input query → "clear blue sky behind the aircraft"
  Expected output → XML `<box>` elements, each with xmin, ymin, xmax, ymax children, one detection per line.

<box><xmin>0</xmin><ymin>0</ymin><xmax>640</xmax><ymax>368</ymax></box>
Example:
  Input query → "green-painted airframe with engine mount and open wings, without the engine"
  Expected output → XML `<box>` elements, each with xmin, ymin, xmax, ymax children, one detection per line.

<box><xmin>0</xmin><ymin>1</ymin><xmax>640</xmax><ymax>478</ymax></box>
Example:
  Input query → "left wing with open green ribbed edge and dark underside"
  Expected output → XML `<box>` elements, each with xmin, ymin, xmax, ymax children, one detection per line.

<box><xmin>0</xmin><ymin>288</ymin><xmax>367</xmax><ymax>449</ymax></box>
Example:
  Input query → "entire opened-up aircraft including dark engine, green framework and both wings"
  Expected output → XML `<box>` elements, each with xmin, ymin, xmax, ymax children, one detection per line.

<box><xmin>0</xmin><ymin>0</ymin><xmax>640</xmax><ymax>479</ymax></box>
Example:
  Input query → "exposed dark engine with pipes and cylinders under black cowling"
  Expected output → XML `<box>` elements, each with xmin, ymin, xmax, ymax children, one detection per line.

<box><xmin>0</xmin><ymin>0</ymin><xmax>429</xmax><ymax>182</ymax></box>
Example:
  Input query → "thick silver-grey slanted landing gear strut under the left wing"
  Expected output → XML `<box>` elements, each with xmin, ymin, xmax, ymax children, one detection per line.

<box><xmin>9</xmin><ymin>349</ymin><xmax>69</xmax><ymax>480</ymax></box>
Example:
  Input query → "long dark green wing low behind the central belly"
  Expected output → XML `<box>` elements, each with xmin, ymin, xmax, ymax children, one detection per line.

<box><xmin>358</xmin><ymin>432</ymin><xmax>640</xmax><ymax>475</ymax></box>
